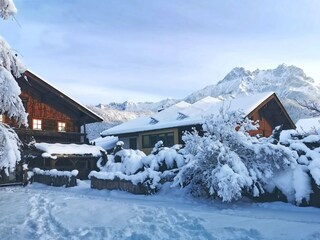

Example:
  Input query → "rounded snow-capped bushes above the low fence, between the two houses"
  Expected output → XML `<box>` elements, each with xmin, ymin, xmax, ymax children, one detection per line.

<box><xmin>89</xmin><ymin>141</ymin><xmax>185</xmax><ymax>189</ymax></box>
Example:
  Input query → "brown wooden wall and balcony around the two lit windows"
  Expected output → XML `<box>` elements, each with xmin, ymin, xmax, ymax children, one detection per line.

<box><xmin>2</xmin><ymin>83</ymin><xmax>85</xmax><ymax>144</ymax></box>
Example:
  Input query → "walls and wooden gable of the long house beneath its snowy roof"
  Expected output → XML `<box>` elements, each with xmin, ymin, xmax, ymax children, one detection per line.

<box><xmin>112</xmin><ymin>94</ymin><xmax>296</xmax><ymax>154</ymax></box>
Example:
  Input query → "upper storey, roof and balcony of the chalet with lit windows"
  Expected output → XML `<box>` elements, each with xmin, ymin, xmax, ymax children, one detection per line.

<box><xmin>0</xmin><ymin>71</ymin><xmax>103</xmax><ymax>143</ymax></box>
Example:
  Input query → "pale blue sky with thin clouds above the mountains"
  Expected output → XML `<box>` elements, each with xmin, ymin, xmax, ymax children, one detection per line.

<box><xmin>0</xmin><ymin>0</ymin><xmax>320</xmax><ymax>104</ymax></box>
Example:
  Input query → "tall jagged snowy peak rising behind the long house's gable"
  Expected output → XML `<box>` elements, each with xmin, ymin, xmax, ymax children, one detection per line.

<box><xmin>184</xmin><ymin>64</ymin><xmax>320</xmax><ymax>122</ymax></box>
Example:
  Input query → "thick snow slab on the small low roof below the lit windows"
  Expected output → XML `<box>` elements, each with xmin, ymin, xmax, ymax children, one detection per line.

<box><xmin>35</xmin><ymin>143</ymin><xmax>105</xmax><ymax>158</ymax></box>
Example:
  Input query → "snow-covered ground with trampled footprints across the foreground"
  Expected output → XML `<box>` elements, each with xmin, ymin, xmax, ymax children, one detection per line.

<box><xmin>0</xmin><ymin>181</ymin><xmax>320</xmax><ymax>240</ymax></box>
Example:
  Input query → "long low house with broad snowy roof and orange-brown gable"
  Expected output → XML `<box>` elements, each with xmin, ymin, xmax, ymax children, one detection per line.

<box><xmin>101</xmin><ymin>92</ymin><xmax>295</xmax><ymax>154</ymax></box>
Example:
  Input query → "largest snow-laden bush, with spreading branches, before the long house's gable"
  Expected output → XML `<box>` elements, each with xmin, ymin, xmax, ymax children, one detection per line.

<box><xmin>175</xmin><ymin>109</ymin><xmax>295</xmax><ymax>201</ymax></box>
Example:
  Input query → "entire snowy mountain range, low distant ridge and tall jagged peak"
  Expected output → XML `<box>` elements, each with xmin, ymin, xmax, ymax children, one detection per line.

<box><xmin>88</xmin><ymin>64</ymin><xmax>320</xmax><ymax>139</ymax></box>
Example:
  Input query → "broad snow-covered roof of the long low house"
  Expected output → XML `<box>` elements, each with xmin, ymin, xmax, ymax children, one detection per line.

<box><xmin>101</xmin><ymin>92</ymin><xmax>274</xmax><ymax>136</ymax></box>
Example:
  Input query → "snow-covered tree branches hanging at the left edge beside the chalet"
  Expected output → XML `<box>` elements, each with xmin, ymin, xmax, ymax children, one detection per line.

<box><xmin>0</xmin><ymin>0</ymin><xmax>27</xmax><ymax>174</ymax></box>
